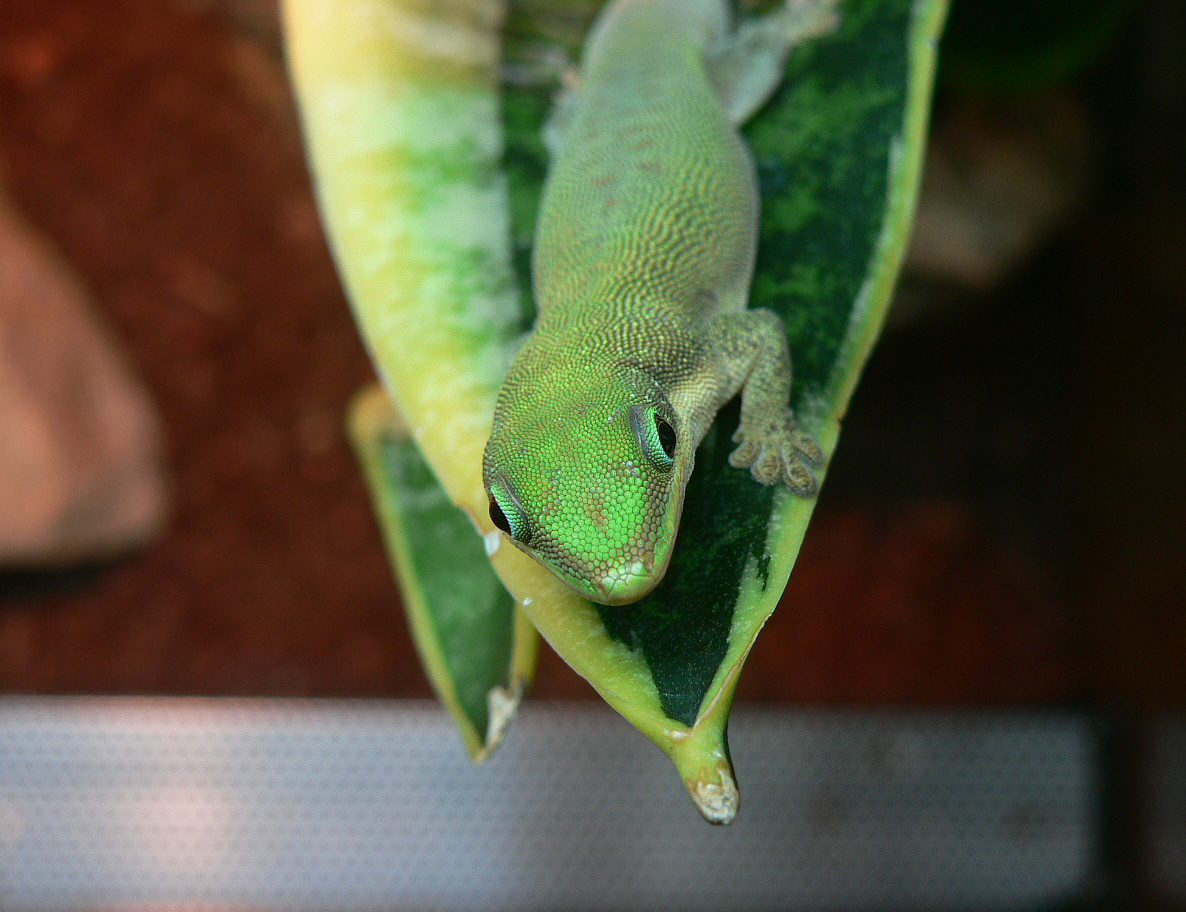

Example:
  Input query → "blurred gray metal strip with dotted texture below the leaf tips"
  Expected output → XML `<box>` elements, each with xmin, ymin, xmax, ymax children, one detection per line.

<box><xmin>0</xmin><ymin>699</ymin><xmax>1101</xmax><ymax>912</ymax></box>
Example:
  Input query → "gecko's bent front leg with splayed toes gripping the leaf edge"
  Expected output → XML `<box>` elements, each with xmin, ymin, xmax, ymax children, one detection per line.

<box><xmin>709</xmin><ymin>308</ymin><xmax>824</xmax><ymax>497</ymax></box>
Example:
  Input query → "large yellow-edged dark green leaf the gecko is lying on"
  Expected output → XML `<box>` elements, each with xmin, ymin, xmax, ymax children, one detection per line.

<box><xmin>286</xmin><ymin>0</ymin><xmax>945</xmax><ymax>822</ymax></box>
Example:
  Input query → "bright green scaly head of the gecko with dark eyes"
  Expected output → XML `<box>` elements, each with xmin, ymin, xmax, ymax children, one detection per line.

<box><xmin>483</xmin><ymin>366</ymin><xmax>693</xmax><ymax>605</ymax></box>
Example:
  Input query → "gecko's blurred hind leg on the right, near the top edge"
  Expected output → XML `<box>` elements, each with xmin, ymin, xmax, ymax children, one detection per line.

<box><xmin>704</xmin><ymin>0</ymin><xmax>841</xmax><ymax>125</ymax></box>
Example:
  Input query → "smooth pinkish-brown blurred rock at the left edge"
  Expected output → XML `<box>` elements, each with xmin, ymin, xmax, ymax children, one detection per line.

<box><xmin>0</xmin><ymin>182</ymin><xmax>167</xmax><ymax>567</ymax></box>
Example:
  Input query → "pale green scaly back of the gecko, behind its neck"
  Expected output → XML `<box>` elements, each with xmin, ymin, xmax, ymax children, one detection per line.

<box><xmin>533</xmin><ymin>0</ymin><xmax>758</xmax><ymax>322</ymax></box>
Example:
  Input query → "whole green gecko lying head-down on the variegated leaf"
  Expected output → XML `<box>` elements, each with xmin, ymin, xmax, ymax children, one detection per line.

<box><xmin>483</xmin><ymin>0</ymin><xmax>837</xmax><ymax>605</ymax></box>
